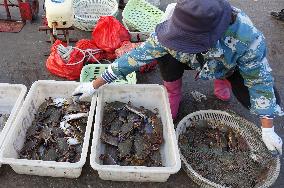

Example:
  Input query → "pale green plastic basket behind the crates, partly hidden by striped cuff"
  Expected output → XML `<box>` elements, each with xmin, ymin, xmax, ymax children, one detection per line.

<box><xmin>80</xmin><ymin>64</ymin><xmax>137</xmax><ymax>84</ymax></box>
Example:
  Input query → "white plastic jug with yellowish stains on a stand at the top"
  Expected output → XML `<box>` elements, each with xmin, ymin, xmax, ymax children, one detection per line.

<box><xmin>45</xmin><ymin>0</ymin><xmax>74</xmax><ymax>28</ymax></box>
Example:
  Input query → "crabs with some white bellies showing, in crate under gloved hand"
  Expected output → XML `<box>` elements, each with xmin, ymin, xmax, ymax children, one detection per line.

<box><xmin>19</xmin><ymin>98</ymin><xmax>90</xmax><ymax>163</ymax></box>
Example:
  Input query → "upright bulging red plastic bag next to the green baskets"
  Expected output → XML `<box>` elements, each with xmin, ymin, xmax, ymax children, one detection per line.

<box><xmin>92</xmin><ymin>16</ymin><xmax>130</xmax><ymax>53</ymax></box>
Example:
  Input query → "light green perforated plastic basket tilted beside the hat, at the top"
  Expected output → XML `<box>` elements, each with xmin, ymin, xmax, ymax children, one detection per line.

<box><xmin>122</xmin><ymin>0</ymin><xmax>164</xmax><ymax>32</ymax></box>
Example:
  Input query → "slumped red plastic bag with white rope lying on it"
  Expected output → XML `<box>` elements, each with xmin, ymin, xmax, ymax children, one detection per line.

<box><xmin>46</xmin><ymin>40</ymin><xmax>83</xmax><ymax>80</ymax></box>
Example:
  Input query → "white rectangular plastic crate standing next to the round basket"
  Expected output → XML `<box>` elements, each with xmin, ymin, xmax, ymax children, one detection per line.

<box><xmin>90</xmin><ymin>84</ymin><xmax>181</xmax><ymax>182</ymax></box>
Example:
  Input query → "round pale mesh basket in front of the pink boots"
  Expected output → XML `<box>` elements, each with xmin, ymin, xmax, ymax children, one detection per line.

<box><xmin>176</xmin><ymin>110</ymin><xmax>280</xmax><ymax>188</ymax></box>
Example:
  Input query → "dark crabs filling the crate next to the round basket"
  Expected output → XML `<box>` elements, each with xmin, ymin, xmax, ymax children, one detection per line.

<box><xmin>100</xmin><ymin>101</ymin><xmax>163</xmax><ymax>167</ymax></box>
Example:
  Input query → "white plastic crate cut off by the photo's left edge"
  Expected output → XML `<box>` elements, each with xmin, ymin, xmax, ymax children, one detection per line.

<box><xmin>0</xmin><ymin>83</ymin><xmax>27</xmax><ymax>166</ymax></box>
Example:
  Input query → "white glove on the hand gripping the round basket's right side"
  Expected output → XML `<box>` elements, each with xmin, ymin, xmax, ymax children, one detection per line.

<box><xmin>262</xmin><ymin>127</ymin><xmax>282</xmax><ymax>155</ymax></box>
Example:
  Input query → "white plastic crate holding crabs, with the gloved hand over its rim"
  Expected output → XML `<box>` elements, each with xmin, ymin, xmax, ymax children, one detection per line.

<box><xmin>0</xmin><ymin>80</ymin><xmax>95</xmax><ymax>178</ymax></box>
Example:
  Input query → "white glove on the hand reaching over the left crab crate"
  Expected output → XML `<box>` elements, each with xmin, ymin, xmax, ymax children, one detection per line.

<box><xmin>72</xmin><ymin>82</ymin><xmax>96</xmax><ymax>100</ymax></box>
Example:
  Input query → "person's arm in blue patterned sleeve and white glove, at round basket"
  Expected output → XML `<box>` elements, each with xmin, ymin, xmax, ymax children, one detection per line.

<box><xmin>238</xmin><ymin>35</ymin><xmax>283</xmax><ymax>154</ymax></box>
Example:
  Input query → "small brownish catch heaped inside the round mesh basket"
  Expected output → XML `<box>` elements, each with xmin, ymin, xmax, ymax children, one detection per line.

<box><xmin>178</xmin><ymin>120</ymin><xmax>273</xmax><ymax>187</ymax></box>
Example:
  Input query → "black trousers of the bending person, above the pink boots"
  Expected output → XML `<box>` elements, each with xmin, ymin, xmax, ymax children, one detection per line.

<box><xmin>157</xmin><ymin>54</ymin><xmax>281</xmax><ymax>109</ymax></box>
